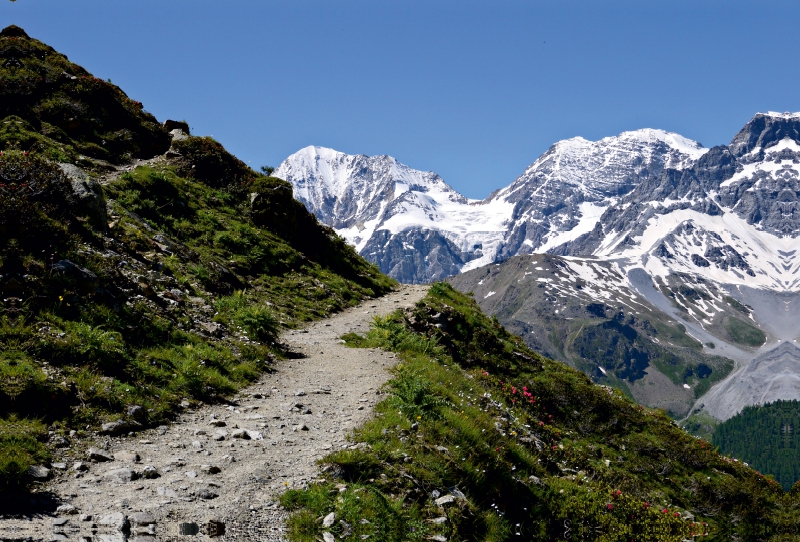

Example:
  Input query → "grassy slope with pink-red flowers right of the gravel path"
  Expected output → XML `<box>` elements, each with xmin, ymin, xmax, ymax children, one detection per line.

<box><xmin>283</xmin><ymin>284</ymin><xmax>798</xmax><ymax>541</ymax></box>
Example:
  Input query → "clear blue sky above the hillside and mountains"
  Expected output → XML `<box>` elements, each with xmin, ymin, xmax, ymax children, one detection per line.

<box><xmin>0</xmin><ymin>0</ymin><xmax>800</xmax><ymax>198</ymax></box>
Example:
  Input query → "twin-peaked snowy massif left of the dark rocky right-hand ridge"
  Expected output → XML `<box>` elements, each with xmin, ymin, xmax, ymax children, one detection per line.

<box><xmin>274</xmin><ymin>129</ymin><xmax>707</xmax><ymax>282</ymax></box>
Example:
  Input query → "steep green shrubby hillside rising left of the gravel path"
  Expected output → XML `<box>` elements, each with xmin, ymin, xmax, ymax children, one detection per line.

<box><xmin>0</xmin><ymin>27</ymin><xmax>394</xmax><ymax>499</ymax></box>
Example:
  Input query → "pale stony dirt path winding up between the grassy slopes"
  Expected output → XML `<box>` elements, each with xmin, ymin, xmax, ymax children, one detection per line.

<box><xmin>0</xmin><ymin>285</ymin><xmax>428</xmax><ymax>542</ymax></box>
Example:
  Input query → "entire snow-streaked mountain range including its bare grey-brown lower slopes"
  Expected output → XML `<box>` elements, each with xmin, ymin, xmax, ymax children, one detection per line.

<box><xmin>275</xmin><ymin>112</ymin><xmax>800</xmax><ymax>420</ymax></box>
